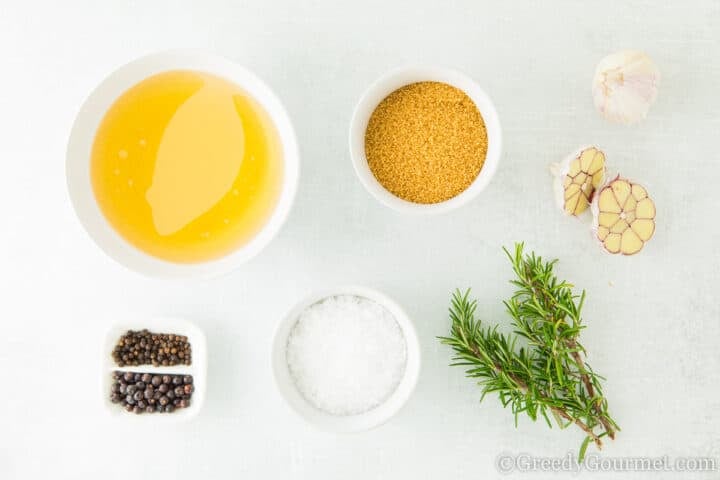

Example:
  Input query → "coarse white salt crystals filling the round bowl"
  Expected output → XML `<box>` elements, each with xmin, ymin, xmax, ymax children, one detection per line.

<box><xmin>286</xmin><ymin>295</ymin><xmax>407</xmax><ymax>416</ymax></box>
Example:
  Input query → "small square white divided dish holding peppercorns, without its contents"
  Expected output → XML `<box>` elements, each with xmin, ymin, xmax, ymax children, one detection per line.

<box><xmin>100</xmin><ymin>317</ymin><xmax>207</xmax><ymax>422</ymax></box>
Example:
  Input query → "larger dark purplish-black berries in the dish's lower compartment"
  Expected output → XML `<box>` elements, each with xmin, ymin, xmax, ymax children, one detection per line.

<box><xmin>110</xmin><ymin>371</ymin><xmax>195</xmax><ymax>414</ymax></box>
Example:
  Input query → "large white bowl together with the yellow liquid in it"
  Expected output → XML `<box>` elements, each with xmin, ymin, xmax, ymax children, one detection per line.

<box><xmin>66</xmin><ymin>51</ymin><xmax>300</xmax><ymax>277</ymax></box>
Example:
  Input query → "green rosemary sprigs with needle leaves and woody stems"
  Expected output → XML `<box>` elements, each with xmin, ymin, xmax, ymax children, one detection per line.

<box><xmin>440</xmin><ymin>243</ymin><xmax>620</xmax><ymax>460</ymax></box>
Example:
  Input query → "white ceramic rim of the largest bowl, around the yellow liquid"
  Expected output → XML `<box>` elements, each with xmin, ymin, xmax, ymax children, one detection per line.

<box><xmin>66</xmin><ymin>51</ymin><xmax>300</xmax><ymax>277</ymax></box>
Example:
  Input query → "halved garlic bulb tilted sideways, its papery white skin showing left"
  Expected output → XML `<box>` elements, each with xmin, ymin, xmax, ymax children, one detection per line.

<box><xmin>552</xmin><ymin>147</ymin><xmax>605</xmax><ymax>216</ymax></box>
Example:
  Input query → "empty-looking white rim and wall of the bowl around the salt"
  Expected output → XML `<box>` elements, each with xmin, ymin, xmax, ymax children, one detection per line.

<box><xmin>272</xmin><ymin>286</ymin><xmax>420</xmax><ymax>433</ymax></box>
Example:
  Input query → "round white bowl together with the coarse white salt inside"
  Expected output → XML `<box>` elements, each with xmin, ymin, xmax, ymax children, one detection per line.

<box><xmin>272</xmin><ymin>287</ymin><xmax>420</xmax><ymax>432</ymax></box>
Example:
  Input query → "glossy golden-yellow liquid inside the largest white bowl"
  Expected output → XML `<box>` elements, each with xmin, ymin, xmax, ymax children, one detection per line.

<box><xmin>90</xmin><ymin>71</ymin><xmax>283</xmax><ymax>263</ymax></box>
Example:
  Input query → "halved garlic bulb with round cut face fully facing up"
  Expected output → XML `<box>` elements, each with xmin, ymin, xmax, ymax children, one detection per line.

<box><xmin>592</xmin><ymin>176</ymin><xmax>655</xmax><ymax>255</ymax></box>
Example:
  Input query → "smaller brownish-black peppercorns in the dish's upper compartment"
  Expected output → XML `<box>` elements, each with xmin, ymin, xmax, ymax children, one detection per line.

<box><xmin>112</xmin><ymin>330</ymin><xmax>192</xmax><ymax>367</ymax></box>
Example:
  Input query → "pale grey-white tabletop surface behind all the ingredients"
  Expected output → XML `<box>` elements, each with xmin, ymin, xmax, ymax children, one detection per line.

<box><xmin>0</xmin><ymin>0</ymin><xmax>720</xmax><ymax>480</ymax></box>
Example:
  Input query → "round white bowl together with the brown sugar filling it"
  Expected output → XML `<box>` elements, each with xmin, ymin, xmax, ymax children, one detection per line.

<box><xmin>350</xmin><ymin>67</ymin><xmax>502</xmax><ymax>213</ymax></box>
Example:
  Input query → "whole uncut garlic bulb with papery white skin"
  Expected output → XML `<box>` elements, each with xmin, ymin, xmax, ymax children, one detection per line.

<box><xmin>593</xmin><ymin>50</ymin><xmax>660</xmax><ymax>125</ymax></box>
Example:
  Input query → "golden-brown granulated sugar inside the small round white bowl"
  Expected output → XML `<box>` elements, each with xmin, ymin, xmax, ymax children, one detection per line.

<box><xmin>365</xmin><ymin>82</ymin><xmax>487</xmax><ymax>203</ymax></box>
